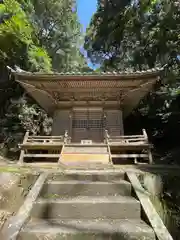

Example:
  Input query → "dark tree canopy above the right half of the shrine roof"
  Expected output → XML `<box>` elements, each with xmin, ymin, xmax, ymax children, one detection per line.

<box><xmin>85</xmin><ymin>0</ymin><xmax>180</xmax><ymax>70</ymax></box>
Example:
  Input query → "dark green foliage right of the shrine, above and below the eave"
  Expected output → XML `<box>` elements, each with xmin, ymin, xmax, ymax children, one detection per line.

<box><xmin>84</xmin><ymin>0</ymin><xmax>180</xmax><ymax>149</ymax></box>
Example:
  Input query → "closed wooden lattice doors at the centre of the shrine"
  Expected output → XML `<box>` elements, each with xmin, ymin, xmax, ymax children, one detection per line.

<box><xmin>72</xmin><ymin>108</ymin><xmax>105</xmax><ymax>142</ymax></box>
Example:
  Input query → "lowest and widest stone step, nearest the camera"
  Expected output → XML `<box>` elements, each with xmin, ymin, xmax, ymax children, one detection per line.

<box><xmin>18</xmin><ymin>219</ymin><xmax>156</xmax><ymax>240</ymax></box>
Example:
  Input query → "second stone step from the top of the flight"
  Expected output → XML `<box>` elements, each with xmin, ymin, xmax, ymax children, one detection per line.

<box><xmin>41</xmin><ymin>180</ymin><xmax>131</xmax><ymax>198</ymax></box>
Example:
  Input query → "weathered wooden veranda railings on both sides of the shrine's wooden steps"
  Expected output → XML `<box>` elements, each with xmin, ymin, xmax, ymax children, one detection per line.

<box><xmin>19</xmin><ymin>129</ymin><xmax>152</xmax><ymax>163</ymax></box>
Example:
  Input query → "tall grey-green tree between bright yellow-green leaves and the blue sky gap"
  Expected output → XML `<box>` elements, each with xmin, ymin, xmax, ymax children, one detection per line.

<box><xmin>22</xmin><ymin>0</ymin><xmax>86</xmax><ymax>71</ymax></box>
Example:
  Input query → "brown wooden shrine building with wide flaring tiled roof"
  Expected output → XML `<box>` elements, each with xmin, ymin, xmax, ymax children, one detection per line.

<box><xmin>10</xmin><ymin>68</ymin><xmax>163</xmax><ymax>165</ymax></box>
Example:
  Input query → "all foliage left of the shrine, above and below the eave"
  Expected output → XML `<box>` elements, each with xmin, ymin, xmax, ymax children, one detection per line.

<box><xmin>0</xmin><ymin>0</ymin><xmax>89</xmax><ymax>156</ymax></box>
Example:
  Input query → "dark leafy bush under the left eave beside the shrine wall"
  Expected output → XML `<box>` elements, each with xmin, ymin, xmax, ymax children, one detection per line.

<box><xmin>0</xmin><ymin>97</ymin><xmax>52</xmax><ymax>157</ymax></box>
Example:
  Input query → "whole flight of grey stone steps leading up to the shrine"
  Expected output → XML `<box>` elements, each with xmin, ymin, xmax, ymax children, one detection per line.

<box><xmin>18</xmin><ymin>170</ymin><xmax>156</xmax><ymax>240</ymax></box>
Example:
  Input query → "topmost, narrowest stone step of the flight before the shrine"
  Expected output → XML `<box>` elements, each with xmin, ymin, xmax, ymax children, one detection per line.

<box><xmin>48</xmin><ymin>170</ymin><xmax>125</xmax><ymax>182</ymax></box>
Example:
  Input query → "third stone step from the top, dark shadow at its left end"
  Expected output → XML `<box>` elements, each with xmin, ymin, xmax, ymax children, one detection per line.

<box><xmin>31</xmin><ymin>196</ymin><xmax>141</xmax><ymax>219</ymax></box>
